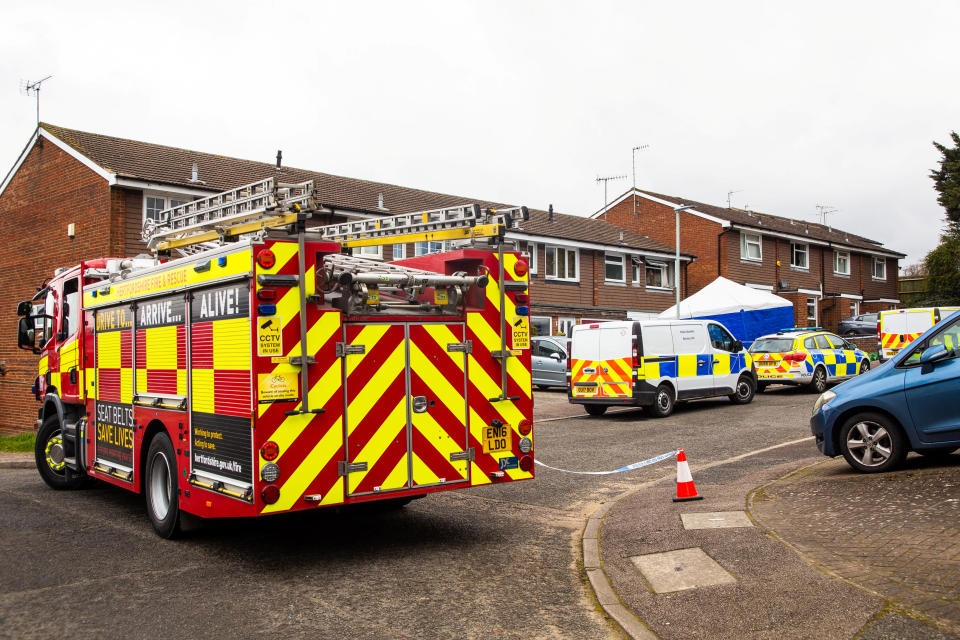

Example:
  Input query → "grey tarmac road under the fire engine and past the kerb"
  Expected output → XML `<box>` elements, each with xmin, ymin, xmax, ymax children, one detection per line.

<box><xmin>0</xmin><ymin>389</ymin><xmax>815</xmax><ymax>638</ymax></box>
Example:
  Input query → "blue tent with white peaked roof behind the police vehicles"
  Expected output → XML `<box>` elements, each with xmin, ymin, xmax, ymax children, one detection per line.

<box><xmin>660</xmin><ymin>277</ymin><xmax>794</xmax><ymax>345</ymax></box>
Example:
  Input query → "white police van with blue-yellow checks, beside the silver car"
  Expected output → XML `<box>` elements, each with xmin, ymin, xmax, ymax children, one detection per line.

<box><xmin>567</xmin><ymin>320</ymin><xmax>757</xmax><ymax>418</ymax></box>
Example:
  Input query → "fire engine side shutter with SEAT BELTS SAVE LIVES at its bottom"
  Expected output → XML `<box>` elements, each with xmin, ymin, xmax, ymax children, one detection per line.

<box><xmin>94</xmin><ymin>305</ymin><xmax>135</xmax><ymax>470</ymax></box>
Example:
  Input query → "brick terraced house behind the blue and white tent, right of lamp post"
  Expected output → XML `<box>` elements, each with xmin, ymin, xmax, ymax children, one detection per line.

<box><xmin>591</xmin><ymin>189</ymin><xmax>905</xmax><ymax>330</ymax></box>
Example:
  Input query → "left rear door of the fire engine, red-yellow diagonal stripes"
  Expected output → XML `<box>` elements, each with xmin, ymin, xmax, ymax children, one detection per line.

<box><xmin>344</xmin><ymin>324</ymin><xmax>409</xmax><ymax>495</ymax></box>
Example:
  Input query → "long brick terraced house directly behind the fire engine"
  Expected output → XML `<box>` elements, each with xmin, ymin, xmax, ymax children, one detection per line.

<box><xmin>0</xmin><ymin>123</ymin><xmax>694</xmax><ymax>436</ymax></box>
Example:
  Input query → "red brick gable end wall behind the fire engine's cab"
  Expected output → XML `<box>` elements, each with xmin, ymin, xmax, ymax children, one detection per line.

<box><xmin>0</xmin><ymin>139</ymin><xmax>117</xmax><ymax>430</ymax></box>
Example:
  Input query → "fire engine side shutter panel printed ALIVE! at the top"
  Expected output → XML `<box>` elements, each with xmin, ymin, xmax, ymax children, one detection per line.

<box><xmin>190</xmin><ymin>281</ymin><xmax>253</xmax><ymax>484</ymax></box>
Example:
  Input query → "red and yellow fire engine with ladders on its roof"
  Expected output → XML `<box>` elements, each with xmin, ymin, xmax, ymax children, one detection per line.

<box><xmin>18</xmin><ymin>178</ymin><xmax>534</xmax><ymax>537</ymax></box>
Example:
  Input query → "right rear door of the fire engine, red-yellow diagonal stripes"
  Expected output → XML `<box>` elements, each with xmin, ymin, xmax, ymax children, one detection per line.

<box><xmin>408</xmin><ymin>324</ymin><xmax>469</xmax><ymax>486</ymax></box>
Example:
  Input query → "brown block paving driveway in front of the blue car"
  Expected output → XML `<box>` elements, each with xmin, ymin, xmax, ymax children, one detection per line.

<box><xmin>754</xmin><ymin>455</ymin><xmax>960</xmax><ymax>632</ymax></box>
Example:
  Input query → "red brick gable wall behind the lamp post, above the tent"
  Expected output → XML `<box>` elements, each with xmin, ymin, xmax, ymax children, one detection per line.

<box><xmin>599</xmin><ymin>197</ymin><xmax>721</xmax><ymax>294</ymax></box>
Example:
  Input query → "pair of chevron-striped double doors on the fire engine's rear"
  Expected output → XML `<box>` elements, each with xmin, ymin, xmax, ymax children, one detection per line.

<box><xmin>344</xmin><ymin>323</ymin><xmax>469</xmax><ymax>495</ymax></box>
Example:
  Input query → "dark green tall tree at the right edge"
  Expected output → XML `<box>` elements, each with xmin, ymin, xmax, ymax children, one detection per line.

<box><xmin>924</xmin><ymin>131</ymin><xmax>960</xmax><ymax>304</ymax></box>
